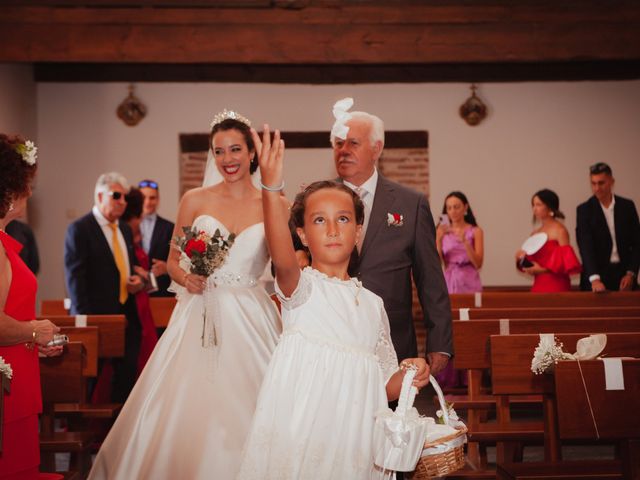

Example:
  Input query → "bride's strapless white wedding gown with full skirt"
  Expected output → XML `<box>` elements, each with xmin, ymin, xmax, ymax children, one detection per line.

<box><xmin>89</xmin><ymin>215</ymin><xmax>281</xmax><ymax>480</ymax></box>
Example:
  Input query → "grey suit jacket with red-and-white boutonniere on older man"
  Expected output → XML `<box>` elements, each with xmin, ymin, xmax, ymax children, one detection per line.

<box><xmin>350</xmin><ymin>175</ymin><xmax>453</xmax><ymax>360</ymax></box>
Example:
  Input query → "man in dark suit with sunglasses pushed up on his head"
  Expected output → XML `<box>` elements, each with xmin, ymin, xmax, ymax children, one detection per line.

<box><xmin>138</xmin><ymin>180</ymin><xmax>174</xmax><ymax>297</ymax></box>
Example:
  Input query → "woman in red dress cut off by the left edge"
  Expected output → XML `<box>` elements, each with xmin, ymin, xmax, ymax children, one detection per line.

<box><xmin>0</xmin><ymin>134</ymin><xmax>62</xmax><ymax>480</ymax></box>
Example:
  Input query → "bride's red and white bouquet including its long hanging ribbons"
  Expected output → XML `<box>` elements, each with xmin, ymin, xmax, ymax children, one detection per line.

<box><xmin>173</xmin><ymin>227</ymin><xmax>236</xmax><ymax>348</ymax></box>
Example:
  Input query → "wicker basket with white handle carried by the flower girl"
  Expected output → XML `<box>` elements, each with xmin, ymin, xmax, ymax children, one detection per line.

<box><xmin>411</xmin><ymin>377</ymin><xmax>467</xmax><ymax>480</ymax></box>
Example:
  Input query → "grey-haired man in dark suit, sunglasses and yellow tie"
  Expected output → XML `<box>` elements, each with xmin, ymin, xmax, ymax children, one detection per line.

<box><xmin>64</xmin><ymin>172</ymin><xmax>144</xmax><ymax>402</ymax></box>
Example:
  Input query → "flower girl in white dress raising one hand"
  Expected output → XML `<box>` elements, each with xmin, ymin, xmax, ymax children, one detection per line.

<box><xmin>237</xmin><ymin>125</ymin><xmax>429</xmax><ymax>480</ymax></box>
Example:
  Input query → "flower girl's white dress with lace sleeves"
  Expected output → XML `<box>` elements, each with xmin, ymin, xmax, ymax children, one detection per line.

<box><xmin>237</xmin><ymin>267</ymin><xmax>398</xmax><ymax>480</ymax></box>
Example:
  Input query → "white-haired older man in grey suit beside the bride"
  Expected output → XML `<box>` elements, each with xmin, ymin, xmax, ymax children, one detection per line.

<box><xmin>331</xmin><ymin>102</ymin><xmax>453</xmax><ymax>374</ymax></box>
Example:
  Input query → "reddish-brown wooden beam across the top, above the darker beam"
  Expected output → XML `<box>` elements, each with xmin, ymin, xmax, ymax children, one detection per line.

<box><xmin>0</xmin><ymin>0</ymin><xmax>640</xmax><ymax>65</ymax></box>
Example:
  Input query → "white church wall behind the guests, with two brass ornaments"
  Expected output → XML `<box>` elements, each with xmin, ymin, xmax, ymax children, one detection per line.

<box><xmin>28</xmin><ymin>81</ymin><xmax>640</xmax><ymax>298</ymax></box>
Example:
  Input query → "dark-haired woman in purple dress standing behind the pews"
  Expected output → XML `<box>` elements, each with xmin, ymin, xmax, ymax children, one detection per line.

<box><xmin>436</xmin><ymin>192</ymin><xmax>484</xmax><ymax>388</ymax></box>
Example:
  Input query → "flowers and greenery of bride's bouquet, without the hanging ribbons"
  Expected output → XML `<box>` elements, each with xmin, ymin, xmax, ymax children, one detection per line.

<box><xmin>173</xmin><ymin>227</ymin><xmax>236</xmax><ymax>277</ymax></box>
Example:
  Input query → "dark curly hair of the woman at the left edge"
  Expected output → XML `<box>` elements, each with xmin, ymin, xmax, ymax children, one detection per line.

<box><xmin>0</xmin><ymin>133</ymin><xmax>38</xmax><ymax>218</ymax></box>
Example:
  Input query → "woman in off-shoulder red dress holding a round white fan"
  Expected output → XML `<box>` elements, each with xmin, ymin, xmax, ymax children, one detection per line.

<box><xmin>516</xmin><ymin>188</ymin><xmax>582</xmax><ymax>292</ymax></box>
